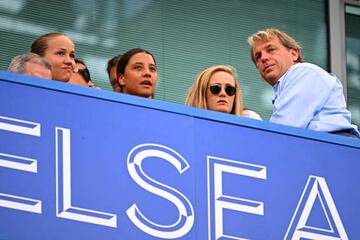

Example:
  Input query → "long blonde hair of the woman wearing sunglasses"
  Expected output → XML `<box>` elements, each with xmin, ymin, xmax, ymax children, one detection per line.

<box><xmin>185</xmin><ymin>65</ymin><xmax>243</xmax><ymax>116</ymax></box>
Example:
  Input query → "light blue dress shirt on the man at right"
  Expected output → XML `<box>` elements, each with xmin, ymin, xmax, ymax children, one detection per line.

<box><xmin>270</xmin><ymin>63</ymin><xmax>360</xmax><ymax>137</ymax></box>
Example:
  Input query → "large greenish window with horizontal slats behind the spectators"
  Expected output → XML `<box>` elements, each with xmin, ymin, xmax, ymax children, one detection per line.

<box><xmin>0</xmin><ymin>0</ymin><xmax>328</xmax><ymax>120</ymax></box>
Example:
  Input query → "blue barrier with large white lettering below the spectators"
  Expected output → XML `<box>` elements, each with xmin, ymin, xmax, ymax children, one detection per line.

<box><xmin>0</xmin><ymin>72</ymin><xmax>360</xmax><ymax>240</ymax></box>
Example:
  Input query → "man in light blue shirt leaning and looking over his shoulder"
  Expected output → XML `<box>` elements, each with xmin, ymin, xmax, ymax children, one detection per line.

<box><xmin>248</xmin><ymin>29</ymin><xmax>360</xmax><ymax>138</ymax></box>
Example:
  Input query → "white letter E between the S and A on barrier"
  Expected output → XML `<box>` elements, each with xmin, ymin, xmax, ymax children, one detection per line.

<box><xmin>207</xmin><ymin>156</ymin><xmax>266</xmax><ymax>240</ymax></box>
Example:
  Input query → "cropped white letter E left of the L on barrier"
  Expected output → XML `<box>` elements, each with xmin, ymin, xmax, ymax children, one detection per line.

<box><xmin>0</xmin><ymin>116</ymin><xmax>41</xmax><ymax>214</ymax></box>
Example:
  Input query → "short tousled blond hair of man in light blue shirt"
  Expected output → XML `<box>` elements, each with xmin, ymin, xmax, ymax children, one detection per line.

<box><xmin>248</xmin><ymin>28</ymin><xmax>304</xmax><ymax>63</ymax></box>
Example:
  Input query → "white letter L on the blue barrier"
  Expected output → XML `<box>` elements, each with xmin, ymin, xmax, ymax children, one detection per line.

<box><xmin>55</xmin><ymin>127</ymin><xmax>117</xmax><ymax>228</ymax></box>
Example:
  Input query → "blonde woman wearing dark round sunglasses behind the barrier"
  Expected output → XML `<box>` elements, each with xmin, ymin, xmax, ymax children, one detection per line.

<box><xmin>185</xmin><ymin>65</ymin><xmax>243</xmax><ymax>116</ymax></box>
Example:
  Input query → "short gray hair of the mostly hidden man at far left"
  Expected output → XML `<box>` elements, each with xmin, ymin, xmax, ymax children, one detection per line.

<box><xmin>8</xmin><ymin>52</ymin><xmax>52</xmax><ymax>74</ymax></box>
